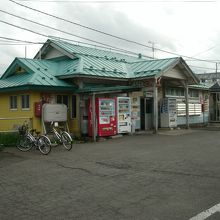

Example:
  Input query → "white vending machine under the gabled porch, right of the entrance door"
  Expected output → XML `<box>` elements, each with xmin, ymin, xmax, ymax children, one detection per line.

<box><xmin>160</xmin><ymin>98</ymin><xmax>177</xmax><ymax>128</ymax></box>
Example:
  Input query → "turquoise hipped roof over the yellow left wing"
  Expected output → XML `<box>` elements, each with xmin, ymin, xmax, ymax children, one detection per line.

<box><xmin>0</xmin><ymin>58</ymin><xmax>75</xmax><ymax>90</ymax></box>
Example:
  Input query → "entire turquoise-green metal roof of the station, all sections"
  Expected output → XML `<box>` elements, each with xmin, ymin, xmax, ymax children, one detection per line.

<box><xmin>0</xmin><ymin>40</ymin><xmax>199</xmax><ymax>91</ymax></box>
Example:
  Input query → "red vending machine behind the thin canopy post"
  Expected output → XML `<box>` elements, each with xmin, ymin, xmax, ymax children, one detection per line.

<box><xmin>88</xmin><ymin>98</ymin><xmax>117</xmax><ymax>137</ymax></box>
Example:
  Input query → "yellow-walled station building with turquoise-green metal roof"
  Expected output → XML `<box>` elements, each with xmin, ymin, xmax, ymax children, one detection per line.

<box><xmin>0</xmin><ymin>39</ymin><xmax>209</xmax><ymax>137</ymax></box>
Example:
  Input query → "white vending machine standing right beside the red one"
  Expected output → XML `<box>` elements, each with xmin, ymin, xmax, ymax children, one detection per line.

<box><xmin>116</xmin><ymin>97</ymin><xmax>131</xmax><ymax>134</ymax></box>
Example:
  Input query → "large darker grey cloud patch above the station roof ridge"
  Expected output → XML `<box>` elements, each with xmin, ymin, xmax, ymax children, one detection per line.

<box><xmin>50</xmin><ymin>5</ymin><xmax>179</xmax><ymax>58</ymax></box>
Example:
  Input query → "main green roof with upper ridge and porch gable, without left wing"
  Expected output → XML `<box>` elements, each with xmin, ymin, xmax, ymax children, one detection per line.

<box><xmin>35</xmin><ymin>39</ymin><xmax>199</xmax><ymax>84</ymax></box>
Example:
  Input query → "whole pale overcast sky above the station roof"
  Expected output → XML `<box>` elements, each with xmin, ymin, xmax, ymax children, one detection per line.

<box><xmin>0</xmin><ymin>0</ymin><xmax>220</xmax><ymax>75</ymax></box>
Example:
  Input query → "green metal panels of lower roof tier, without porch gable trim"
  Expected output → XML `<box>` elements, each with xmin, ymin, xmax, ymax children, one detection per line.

<box><xmin>54</xmin><ymin>55</ymin><xmax>179</xmax><ymax>79</ymax></box>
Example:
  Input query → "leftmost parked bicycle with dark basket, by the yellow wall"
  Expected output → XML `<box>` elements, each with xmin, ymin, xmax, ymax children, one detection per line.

<box><xmin>16</xmin><ymin>123</ymin><xmax>51</xmax><ymax>155</ymax></box>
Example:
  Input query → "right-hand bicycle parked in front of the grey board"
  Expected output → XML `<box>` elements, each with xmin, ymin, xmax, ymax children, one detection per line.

<box><xmin>48</xmin><ymin>121</ymin><xmax>73</xmax><ymax>150</ymax></box>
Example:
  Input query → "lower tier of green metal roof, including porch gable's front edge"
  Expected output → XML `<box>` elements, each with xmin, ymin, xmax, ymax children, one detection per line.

<box><xmin>57</xmin><ymin>55</ymin><xmax>199</xmax><ymax>84</ymax></box>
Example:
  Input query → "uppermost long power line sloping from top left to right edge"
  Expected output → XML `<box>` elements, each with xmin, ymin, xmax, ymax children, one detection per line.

<box><xmin>9</xmin><ymin>0</ymin><xmax>218</xmax><ymax>63</ymax></box>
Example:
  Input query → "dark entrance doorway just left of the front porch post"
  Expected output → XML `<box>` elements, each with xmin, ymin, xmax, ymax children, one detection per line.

<box><xmin>141</xmin><ymin>98</ymin><xmax>153</xmax><ymax>130</ymax></box>
